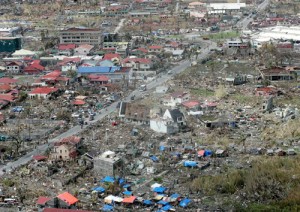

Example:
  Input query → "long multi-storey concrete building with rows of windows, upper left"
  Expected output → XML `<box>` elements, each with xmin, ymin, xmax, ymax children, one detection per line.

<box><xmin>59</xmin><ymin>28</ymin><xmax>102</xmax><ymax>46</ymax></box>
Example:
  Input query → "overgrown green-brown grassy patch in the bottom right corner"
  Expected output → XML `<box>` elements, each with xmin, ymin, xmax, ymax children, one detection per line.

<box><xmin>190</xmin><ymin>156</ymin><xmax>300</xmax><ymax>211</ymax></box>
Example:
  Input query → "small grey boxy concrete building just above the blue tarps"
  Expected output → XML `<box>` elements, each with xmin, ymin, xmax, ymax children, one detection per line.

<box><xmin>94</xmin><ymin>151</ymin><xmax>123</xmax><ymax>176</ymax></box>
